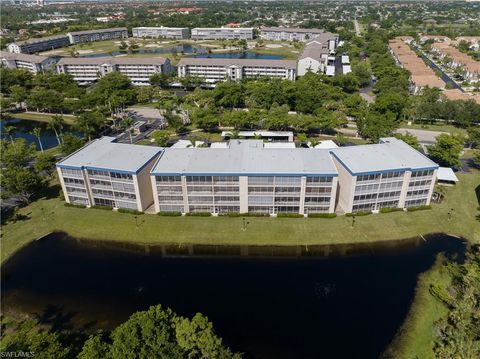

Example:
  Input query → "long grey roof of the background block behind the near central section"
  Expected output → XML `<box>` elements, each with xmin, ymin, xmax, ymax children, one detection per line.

<box><xmin>178</xmin><ymin>57</ymin><xmax>297</xmax><ymax>69</ymax></box>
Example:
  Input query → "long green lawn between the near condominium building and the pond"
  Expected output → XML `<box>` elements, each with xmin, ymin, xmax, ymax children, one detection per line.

<box><xmin>1</xmin><ymin>171</ymin><xmax>480</xmax><ymax>261</ymax></box>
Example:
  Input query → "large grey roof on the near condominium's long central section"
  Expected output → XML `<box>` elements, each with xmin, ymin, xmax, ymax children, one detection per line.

<box><xmin>151</xmin><ymin>140</ymin><xmax>338</xmax><ymax>176</ymax></box>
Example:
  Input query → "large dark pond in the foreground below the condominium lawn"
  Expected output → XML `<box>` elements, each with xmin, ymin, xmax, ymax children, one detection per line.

<box><xmin>2</xmin><ymin>234</ymin><xmax>465</xmax><ymax>358</ymax></box>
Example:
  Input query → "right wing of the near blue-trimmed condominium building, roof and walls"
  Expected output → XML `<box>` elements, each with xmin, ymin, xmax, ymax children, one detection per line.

<box><xmin>330</xmin><ymin>137</ymin><xmax>438</xmax><ymax>213</ymax></box>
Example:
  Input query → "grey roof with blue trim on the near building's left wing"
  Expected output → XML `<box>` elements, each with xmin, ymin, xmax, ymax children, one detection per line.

<box><xmin>57</xmin><ymin>137</ymin><xmax>163</xmax><ymax>173</ymax></box>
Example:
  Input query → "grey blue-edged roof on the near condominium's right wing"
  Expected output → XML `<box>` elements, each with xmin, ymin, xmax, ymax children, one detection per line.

<box><xmin>330</xmin><ymin>137</ymin><xmax>438</xmax><ymax>175</ymax></box>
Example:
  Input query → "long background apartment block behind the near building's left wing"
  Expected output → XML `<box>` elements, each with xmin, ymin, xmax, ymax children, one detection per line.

<box><xmin>57</xmin><ymin>57</ymin><xmax>172</xmax><ymax>85</ymax></box>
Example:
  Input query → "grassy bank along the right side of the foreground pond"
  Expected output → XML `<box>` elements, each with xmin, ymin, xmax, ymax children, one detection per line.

<box><xmin>384</xmin><ymin>258</ymin><xmax>451</xmax><ymax>359</ymax></box>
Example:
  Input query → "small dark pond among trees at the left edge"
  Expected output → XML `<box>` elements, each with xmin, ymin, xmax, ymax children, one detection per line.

<box><xmin>0</xmin><ymin>119</ymin><xmax>78</xmax><ymax>150</ymax></box>
